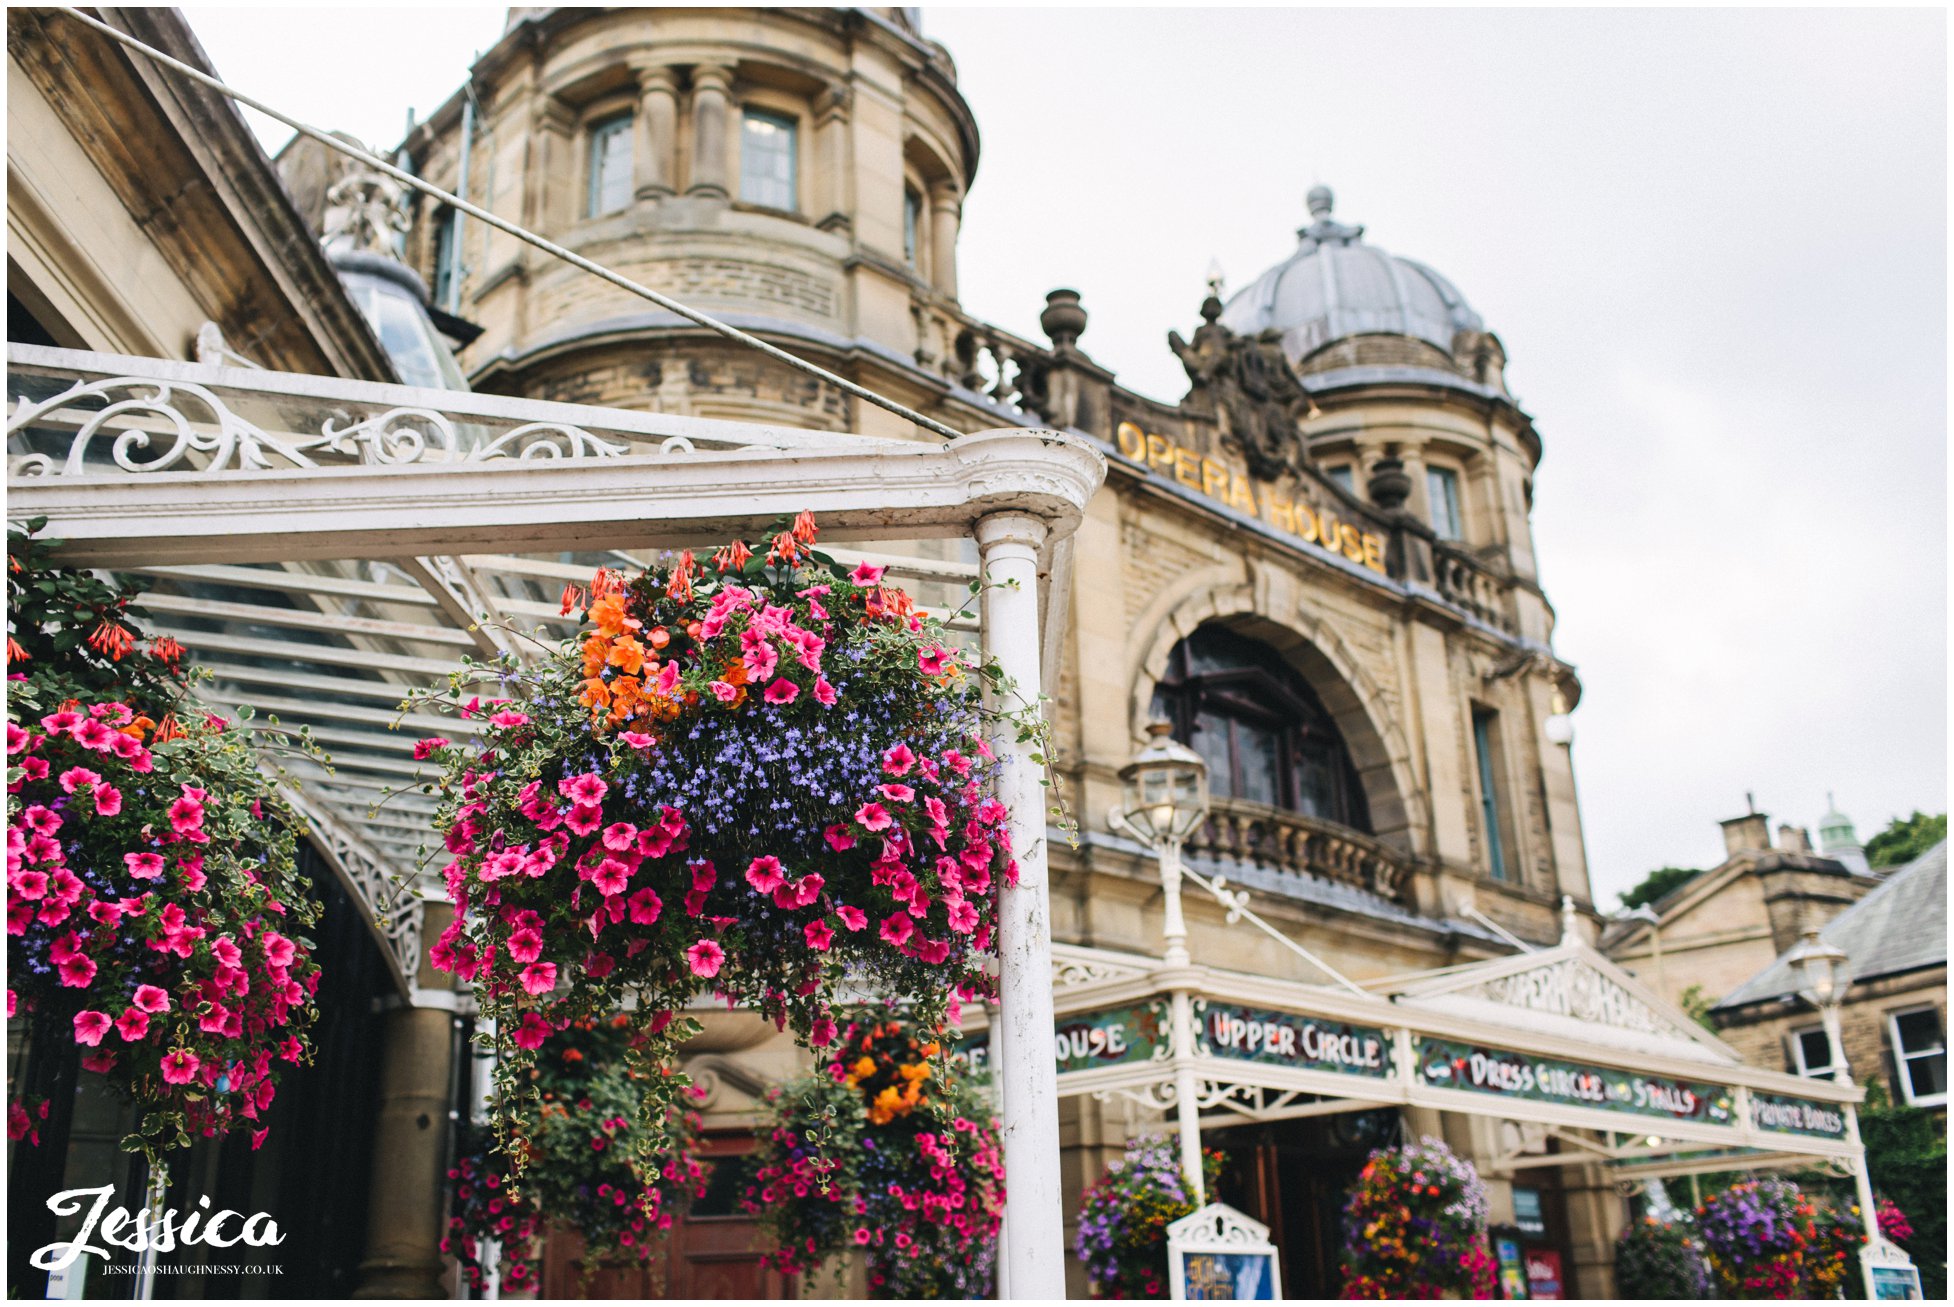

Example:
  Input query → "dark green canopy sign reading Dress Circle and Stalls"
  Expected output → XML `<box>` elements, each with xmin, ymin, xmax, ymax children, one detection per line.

<box><xmin>1415</xmin><ymin>1035</ymin><xmax>1733</xmax><ymax>1125</ymax></box>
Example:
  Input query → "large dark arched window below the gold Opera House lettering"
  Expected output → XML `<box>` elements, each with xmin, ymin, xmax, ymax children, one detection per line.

<box><xmin>1153</xmin><ymin>627</ymin><xmax>1370</xmax><ymax>832</ymax></box>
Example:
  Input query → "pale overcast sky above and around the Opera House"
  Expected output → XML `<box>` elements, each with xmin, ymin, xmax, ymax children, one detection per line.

<box><xmin>186</xmin><ymin>8</ymin><xmax>1948</xmax><ymax>905</ymax></box>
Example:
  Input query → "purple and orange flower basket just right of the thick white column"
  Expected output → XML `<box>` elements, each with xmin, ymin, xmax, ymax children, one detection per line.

<box><xmin>1075</xmin><ymin>1135</ymin><xmax>1221</xmax><ymax>1297</ymax></box>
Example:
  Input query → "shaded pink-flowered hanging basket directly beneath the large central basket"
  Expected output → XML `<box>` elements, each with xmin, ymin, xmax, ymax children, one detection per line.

<box><xmin>442</xmin><ymin>1016</ymin><xmax>707</xmax><ymax>1289</ymax></box>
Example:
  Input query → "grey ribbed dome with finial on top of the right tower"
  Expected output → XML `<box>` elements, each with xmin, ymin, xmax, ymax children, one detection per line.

<box><xmin>1221</xmin><ymin>186</ymin><xmax>1485</xmax><ymax>361</ymax></box>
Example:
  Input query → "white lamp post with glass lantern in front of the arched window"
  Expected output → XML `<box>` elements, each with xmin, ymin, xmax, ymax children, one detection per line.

<box><xmin>1106</xmin><ymin>721</ymin><xmax>1208</xmax><ymax>1205</ymax></box>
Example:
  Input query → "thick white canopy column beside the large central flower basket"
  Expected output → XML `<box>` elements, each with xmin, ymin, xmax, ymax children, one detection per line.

<box><xmin>977</xmin><ymin>512</ymin><xmax>1065</xmax><ymax>1299</ymax></box>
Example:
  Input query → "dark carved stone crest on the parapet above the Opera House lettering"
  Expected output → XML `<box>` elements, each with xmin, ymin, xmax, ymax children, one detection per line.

<box><xmin>1167</xmin><ymin>295</ymin><xmax>1313</xmax><ymax>481</ymax></box>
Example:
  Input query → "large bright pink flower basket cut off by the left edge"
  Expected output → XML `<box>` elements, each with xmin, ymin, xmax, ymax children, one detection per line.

<box><xmin>6</xmin><ymin>535</ymin><xmax>319</xmax><ymax>1166</ymax></box>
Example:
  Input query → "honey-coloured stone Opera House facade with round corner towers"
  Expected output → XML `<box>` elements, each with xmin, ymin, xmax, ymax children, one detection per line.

<box><xmin>388</xmin><ymin>10</ymin><xmax>1622</xmax><ymax>1295</ymax></box>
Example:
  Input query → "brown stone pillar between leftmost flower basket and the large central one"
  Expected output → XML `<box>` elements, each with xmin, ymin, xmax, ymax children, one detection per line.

<box><xmin>358</xmin><ymin>1008</ymin><xmax>455</xmax><ymax>1297</ymax></box>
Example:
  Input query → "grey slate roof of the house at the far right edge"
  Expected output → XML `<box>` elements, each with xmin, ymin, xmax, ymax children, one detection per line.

<box><xmin>1716</xmin><ymin>840</ymin><xmax>1948</xmax><ymax>1008</ymax></box>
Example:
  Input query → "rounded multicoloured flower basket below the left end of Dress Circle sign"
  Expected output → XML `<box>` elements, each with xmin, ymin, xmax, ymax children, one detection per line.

<box><xmin>1342</xmin><ymin>1135</ymin><xmax>1493</xmax><ymax>1299</ymax></box>
